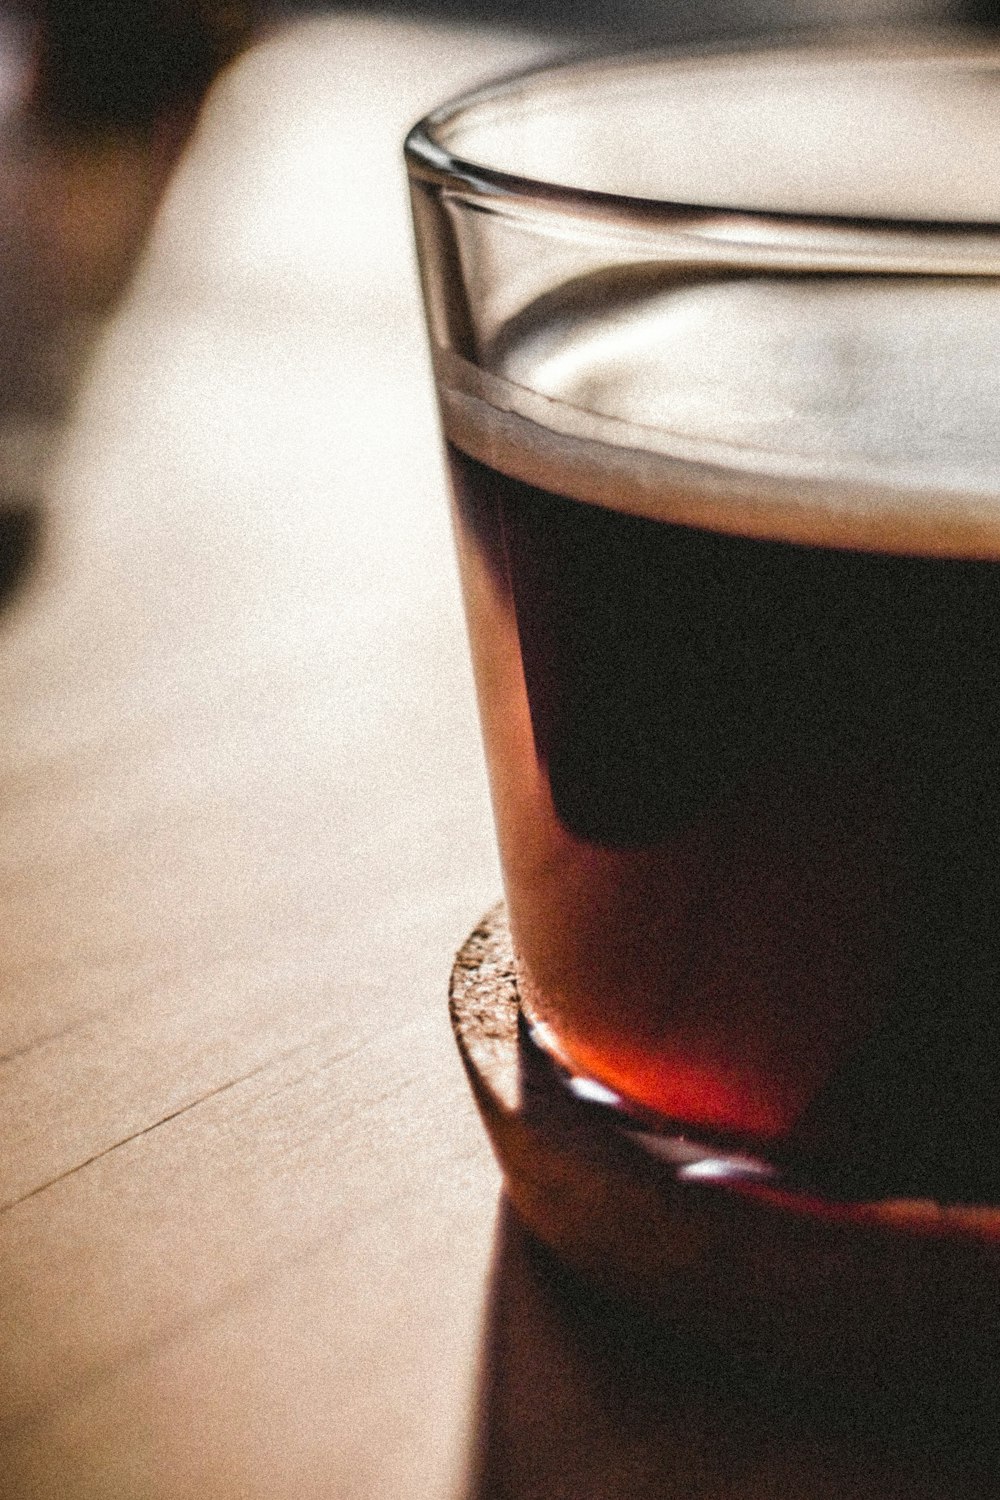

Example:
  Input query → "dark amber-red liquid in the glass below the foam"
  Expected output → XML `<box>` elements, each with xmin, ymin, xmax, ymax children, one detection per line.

<box><xmin>450</xmin><ymin>273</ymin><xmax>1000</xmax><ymax>1203</ymax></box>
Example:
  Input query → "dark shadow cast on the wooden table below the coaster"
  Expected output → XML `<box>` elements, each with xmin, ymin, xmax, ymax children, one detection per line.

<box><xmin>469</xmin><ymin>1202</ymin><xmax>1000</xmax><ymax>1500</ymax></box>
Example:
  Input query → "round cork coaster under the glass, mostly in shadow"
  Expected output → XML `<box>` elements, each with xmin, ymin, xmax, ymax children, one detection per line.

<box><xmin>450</xmin><ymin>905</ymin><xmax>1000</xmax><ymax>1386</ymax></box>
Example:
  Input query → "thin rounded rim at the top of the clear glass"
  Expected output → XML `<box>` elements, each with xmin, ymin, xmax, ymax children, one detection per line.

<box><xmin>403</xmin><ymin>29</ymin><xmax>1000</xmax><ymax>252</ymax></box>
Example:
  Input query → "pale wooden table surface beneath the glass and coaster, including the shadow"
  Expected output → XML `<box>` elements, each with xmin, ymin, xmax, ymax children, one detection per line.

<box><xmin>0</xmin><ymin>15</ymin><xmax>997</xmax><ymax>1500</ymax></box>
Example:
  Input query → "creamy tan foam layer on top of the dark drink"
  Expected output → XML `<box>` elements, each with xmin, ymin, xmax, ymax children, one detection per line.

<box><xmin>441</xmin><ymin>267</ymin><xmax>1000</xmax><ymax>558</ymax></box>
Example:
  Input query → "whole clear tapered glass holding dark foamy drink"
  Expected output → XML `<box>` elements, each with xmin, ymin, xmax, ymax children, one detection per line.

<box><xmin>406</xmin><ymin>41</ymin><xmax>1000</xmax><ymax>1205</ymax></box>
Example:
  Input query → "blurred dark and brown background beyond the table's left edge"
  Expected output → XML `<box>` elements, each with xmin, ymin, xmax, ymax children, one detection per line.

<box><xmin>0</xmin><ymin>0</ymin><xmax>262</xmax><ymax>603</ymax></box>
